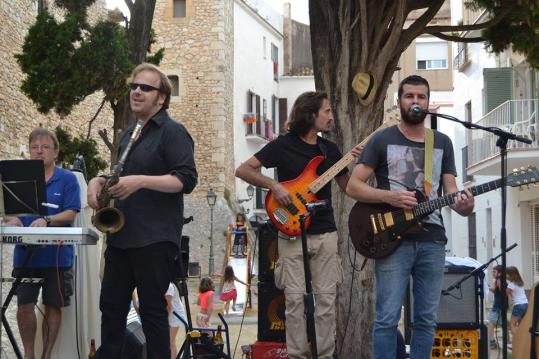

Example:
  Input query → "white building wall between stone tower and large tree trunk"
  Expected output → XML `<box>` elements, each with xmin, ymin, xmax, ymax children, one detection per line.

<box><xmin>233</xmin><ymin>0</ymin><xmax>283</xmax><ymax>209</ymax></box>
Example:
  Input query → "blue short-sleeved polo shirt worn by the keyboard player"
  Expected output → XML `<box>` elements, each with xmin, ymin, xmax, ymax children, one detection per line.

<box><xmin>13</xmin><ymin>167</ymin><xmax>80</xmax><ymax>268</ymax></box>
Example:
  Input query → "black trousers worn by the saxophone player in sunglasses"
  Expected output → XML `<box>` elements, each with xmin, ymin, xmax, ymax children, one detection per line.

<box><xmin>99</xmin><ymin>242</ymin><xmax>178</xmax><ymax>359</ymax></box>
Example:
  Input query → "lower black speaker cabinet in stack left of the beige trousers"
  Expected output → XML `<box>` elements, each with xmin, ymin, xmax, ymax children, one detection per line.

<box><xmin>257</xmin><ymin>282</ymin><xmax>286</xmax><ymax>342</ymax></box>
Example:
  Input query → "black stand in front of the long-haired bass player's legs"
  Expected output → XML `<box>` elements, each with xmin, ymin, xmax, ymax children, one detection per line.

<box><xmin>299</xmin><ymin>201</ymin><xmax>328</xmax><ymax>359</ymax></box>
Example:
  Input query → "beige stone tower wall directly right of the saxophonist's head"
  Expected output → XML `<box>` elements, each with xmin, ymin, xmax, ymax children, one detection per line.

<box><xmin>153</xmin><ymin>0</ymin><xmax>234</xmax><ymax>197</ymax></box>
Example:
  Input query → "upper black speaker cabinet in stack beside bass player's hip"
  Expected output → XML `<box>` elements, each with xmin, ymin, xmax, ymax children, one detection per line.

<box><xmin>258</xmin><ymin>222</ymin><xmax>279</xmax><ymax>283</ymax></box>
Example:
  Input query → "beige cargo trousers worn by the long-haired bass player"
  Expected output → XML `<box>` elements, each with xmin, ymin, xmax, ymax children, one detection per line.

<box><xmin>275</xmin><ymin>232</ymin><xmax>343</xmax><ymax>359</ymax></box>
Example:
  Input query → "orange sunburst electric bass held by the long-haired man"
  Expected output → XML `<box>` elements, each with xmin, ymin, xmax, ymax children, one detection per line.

<box><xmin>265</xmin><ymin>108</ymin><xmax>399</xmax><ymax>237</ymax></box>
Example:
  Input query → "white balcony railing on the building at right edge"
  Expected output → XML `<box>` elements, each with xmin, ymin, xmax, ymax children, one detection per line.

<box><xmin>468</xmin><ymin>99</ymin><xmax>539</xmax><ymax>166</ymax></box>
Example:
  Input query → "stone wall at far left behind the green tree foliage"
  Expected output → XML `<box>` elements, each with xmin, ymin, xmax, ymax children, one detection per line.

<box><xmin>0</xmin><ymin>0</ymin><xmax>113</xmax><ymax>160</ymax></box>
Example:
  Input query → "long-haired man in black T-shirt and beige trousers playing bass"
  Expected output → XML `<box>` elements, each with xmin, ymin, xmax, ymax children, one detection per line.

<box><xmin>236</xmin><ymin>92</ymin><xmax>361</xmax><ymax>359</ymax></box>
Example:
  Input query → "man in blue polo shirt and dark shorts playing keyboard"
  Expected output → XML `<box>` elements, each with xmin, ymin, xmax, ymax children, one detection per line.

<box><xmin>5</xmin><ymin>128</ymin><xmax>80</xmax><ymax>359</ymax></box>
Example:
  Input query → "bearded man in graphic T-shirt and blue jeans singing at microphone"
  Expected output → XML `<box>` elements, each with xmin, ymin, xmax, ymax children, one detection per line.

<box><xmin>347</xmin><ymin>75</ymin><xmax>474</xmax><ymax>359</ymax></box>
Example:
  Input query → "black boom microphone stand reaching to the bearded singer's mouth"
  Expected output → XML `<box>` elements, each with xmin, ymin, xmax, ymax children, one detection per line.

<box><xmin>418</xmin><ymin>107</ymin><xmax>532</xmax><ymax>359</ymax></box>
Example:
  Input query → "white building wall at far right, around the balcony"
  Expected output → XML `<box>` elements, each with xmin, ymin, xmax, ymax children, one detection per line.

<box><xmin>449</xmin><ymin>0</ymin><xmax>539</xmax><ymax>288</ymax></box>
